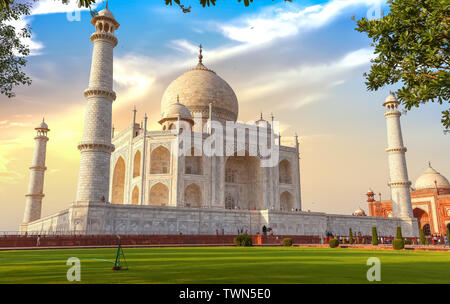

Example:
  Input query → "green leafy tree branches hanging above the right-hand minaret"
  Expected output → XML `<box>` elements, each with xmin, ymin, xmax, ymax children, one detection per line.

<box><xmin>356</xmin><ymin>0</ymin><xmax>450</xmax><ymax>130</ymax></box>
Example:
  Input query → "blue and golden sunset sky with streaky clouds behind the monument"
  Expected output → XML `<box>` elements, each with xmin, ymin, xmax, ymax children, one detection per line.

<box><xmin>0</xmin><ymin>0</ymin><xmax>450</xmax><ymax>231</ymax></box>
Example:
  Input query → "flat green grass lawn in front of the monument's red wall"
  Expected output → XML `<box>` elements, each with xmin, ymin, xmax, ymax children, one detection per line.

<box><xmin>0</xmin><ymin>247</ymin><xmax>450</xmax><ymax>284</ymax></box>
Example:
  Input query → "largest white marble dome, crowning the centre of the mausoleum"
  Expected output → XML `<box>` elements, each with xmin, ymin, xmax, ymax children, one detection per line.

<box><xmin>161</xmin><ymin>62</ymin><xmax>239</xmax><ymax>121</ymax></box>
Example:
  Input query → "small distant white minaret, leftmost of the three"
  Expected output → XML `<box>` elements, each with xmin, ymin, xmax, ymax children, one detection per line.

<box><xmin>23</xmin><ymin>120</ymin><xmax>50</xmax><ymax>224</ymax></box>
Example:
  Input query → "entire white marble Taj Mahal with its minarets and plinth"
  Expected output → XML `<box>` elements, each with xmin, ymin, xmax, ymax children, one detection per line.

<box><xmin>20</xmin><ymin>7</ymin><xmax>418</xmax><ymax>236</ymax></box>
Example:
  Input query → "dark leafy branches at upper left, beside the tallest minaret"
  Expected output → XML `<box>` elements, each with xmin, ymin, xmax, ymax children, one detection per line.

<box><xmin>0</xmin><ymin>0</ymin><xmax>31</xmax><ymax>98</ymax></box>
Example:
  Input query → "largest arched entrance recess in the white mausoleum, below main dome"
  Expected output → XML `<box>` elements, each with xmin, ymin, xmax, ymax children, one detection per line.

<box><xmin>225</xmin><ymin>152</ymin><xmax>263</xmax><ymax>210</ymax></box>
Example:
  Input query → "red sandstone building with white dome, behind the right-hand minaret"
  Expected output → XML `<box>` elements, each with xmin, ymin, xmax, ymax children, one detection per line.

<box><xmin>366</xmin><ymin>163</ymin><xmax>450</xmax><ymax>235</ymax></box>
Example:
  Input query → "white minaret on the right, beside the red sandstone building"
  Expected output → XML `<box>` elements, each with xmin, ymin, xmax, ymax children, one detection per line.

<box><xmin>383</xmin><ymin>92</ymin><xmax>413</xmax><ymax>219</ymax></box>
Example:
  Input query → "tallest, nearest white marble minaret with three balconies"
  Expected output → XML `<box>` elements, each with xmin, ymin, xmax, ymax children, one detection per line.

<box><xmin>77</xmin><ymin>4</ymin><xmax>119</xmax><ymax>203</ymax></box>
